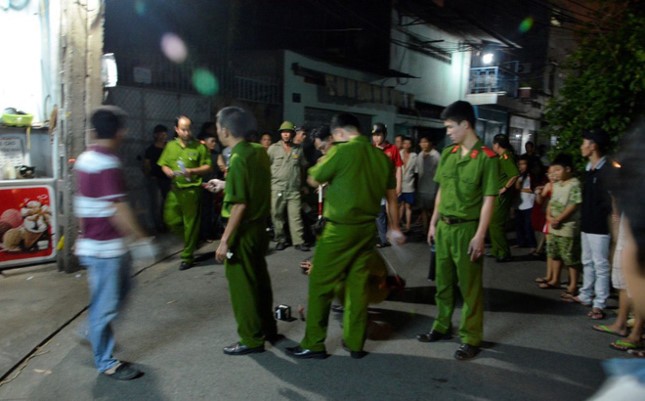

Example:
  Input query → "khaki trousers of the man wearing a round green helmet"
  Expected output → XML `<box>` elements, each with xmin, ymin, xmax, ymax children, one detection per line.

<box><xmin>271</xmin><ymin>190</ymin><xmax>304</xmax><ymax>245</ymax></box>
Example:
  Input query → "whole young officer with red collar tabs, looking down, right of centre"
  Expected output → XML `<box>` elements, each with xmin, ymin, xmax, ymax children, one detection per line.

<box><xmin>417</xmin><ymin>101</ymin><xmax>499</xmax><ymax>360</ymax></box>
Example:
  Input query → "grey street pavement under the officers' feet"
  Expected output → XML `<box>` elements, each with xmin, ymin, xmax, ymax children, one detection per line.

<box><xmin>0</xmin><ymin>234</ymin><xmax>621</xmax><ymax>400</ymax></box>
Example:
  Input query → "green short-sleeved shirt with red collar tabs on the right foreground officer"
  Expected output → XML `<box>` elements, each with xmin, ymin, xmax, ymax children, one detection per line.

<box><xmin>434</xmin><ymin>141</ymin><xmax>499</xmax><ymax>220</ymax></box>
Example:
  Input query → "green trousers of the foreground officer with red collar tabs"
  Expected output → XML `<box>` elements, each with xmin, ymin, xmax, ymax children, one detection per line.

<box><xmin>432</xmin><ymin>221</ymin><xmax>484</xmax><ymax>346</ymax></box>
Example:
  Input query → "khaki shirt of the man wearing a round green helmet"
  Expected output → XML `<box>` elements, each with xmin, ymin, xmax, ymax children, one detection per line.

<box><xmin>267</xmin><ymin>141</ymin><xmax>307</xmax><ymax>191</ymax></box>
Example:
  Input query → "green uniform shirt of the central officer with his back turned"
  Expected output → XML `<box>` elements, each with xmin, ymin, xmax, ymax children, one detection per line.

<box><xmin>309</xmin><ymin>136</ymin><xmax>396</xmax><ymax>224</ymax></box>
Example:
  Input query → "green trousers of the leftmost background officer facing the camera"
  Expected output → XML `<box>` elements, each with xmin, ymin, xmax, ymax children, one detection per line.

<box><xmin>163</xmin><ymin>187</ymin><xmax>202</xmax><ymax>263</ymax></box>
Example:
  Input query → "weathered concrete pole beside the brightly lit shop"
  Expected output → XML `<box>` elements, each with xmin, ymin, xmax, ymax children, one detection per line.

<box><xmin>56</xmin><ymin>0</ymin><xmax>105</xmax><ymax>273</ymax></box>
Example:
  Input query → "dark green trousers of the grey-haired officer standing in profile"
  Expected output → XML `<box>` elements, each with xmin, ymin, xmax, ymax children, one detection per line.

<box><xmin>225</xmin><ymin>219</ymin><xmax>278</xmax><ymax>347</ymax></box>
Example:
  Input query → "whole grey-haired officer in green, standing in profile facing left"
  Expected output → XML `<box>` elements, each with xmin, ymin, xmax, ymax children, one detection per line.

<box><xmin>215</xmin><ymin>107</ymin><xmax>279</xmax><ymax>355</ymax></box>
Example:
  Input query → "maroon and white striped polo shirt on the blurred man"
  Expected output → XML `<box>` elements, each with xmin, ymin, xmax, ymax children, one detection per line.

<box><xmin>74</xmin><ymin>145</ymin><xmax>127</xmax><ymax>258</ymax></box>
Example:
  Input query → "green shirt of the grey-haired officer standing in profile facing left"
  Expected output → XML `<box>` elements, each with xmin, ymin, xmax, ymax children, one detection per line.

<box><xmin>222</xmin><ymin>141</ymin><xmax>271</xmax><ymax>222</ymax></box>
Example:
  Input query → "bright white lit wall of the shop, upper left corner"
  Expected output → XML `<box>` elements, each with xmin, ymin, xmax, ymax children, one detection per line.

<box><xmin>0</xmin><ymin>0</ymin><xmax>60</xmax><ymax>121</ymax></box>
